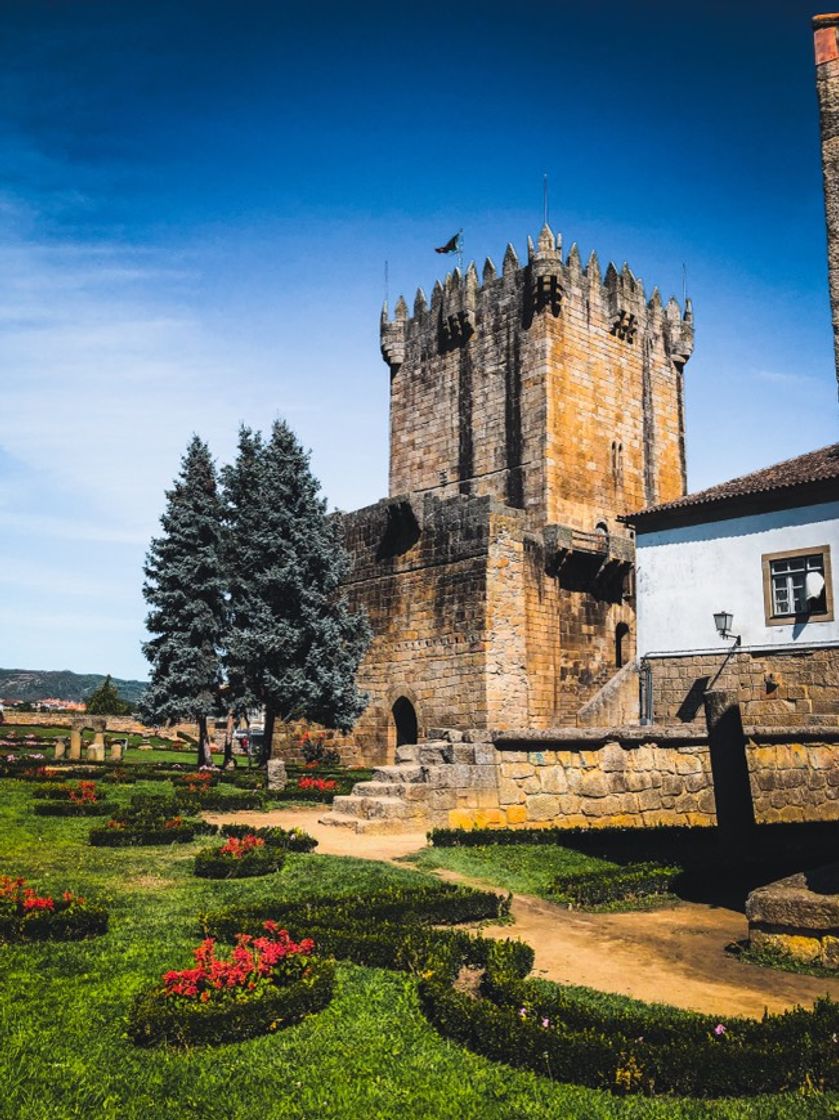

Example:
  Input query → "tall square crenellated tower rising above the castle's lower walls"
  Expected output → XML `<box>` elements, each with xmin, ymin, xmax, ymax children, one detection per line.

<box><xmin>381</xmin><ymin>226</ymin><xmax>692</xmax><ymax>531</ymax></box>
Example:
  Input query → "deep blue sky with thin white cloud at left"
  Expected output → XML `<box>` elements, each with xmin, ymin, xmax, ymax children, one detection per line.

<box><xmin>0</xmin><ymin>0</ymin><xmax>837</xmax><ymax>676</ymax></box>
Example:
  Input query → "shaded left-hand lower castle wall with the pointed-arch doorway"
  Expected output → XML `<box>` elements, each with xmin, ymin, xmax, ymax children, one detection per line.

<box><xmin>343</xmin><ymin>497</ymin><xmax>495</xmax><ymax>764</ymax></box>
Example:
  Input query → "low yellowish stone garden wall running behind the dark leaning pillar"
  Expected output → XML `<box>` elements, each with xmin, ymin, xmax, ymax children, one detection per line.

<box><xmin>429</xmin><ymin>728</ymin><xmax>839</xmax><ymax>828</ymax></box>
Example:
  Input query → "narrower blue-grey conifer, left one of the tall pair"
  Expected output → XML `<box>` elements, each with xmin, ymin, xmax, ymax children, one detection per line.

<box><xmin>141</xmin><ymin>436</ymin><xmax>226</xmax><ymax>766</ymax></box>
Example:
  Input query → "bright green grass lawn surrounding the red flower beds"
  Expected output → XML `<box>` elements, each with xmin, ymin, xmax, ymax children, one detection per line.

<box><xmin>0</xmin><ymin>780</ymin><xmax>839</xmax><ymax>1120</ymax></box>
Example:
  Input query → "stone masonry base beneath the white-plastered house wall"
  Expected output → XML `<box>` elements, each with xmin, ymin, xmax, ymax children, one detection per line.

<box><xmin>646</xmin><ymin>647</ymin><xmax>839</xmax><ymax>728</ymax></box>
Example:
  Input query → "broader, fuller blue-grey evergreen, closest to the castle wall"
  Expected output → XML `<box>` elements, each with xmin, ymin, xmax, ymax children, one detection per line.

<box><xmin>222</xmin><ymin>421</ymin><xmax>371</xmax><ymax>758</ymax></box>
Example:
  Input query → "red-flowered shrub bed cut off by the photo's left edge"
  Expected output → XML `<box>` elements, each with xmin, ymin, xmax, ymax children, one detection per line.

<box><xmin>0</xmin><ymin>875</ymin><xmax>108</xmax><ymax>941</ymax></box>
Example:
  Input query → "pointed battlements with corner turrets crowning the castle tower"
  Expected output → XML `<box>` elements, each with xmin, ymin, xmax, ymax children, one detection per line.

<box><xmin>381</xmin><ymin>225</ymin><xmax>693</xmax><ymax>373</ymax></box>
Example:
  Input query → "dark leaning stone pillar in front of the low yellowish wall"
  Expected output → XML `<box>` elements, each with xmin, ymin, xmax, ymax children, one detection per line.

<box><xmin>705</xmin><ymin>689</ymin><xmax>755</xmax><ymax>841</ymax></box>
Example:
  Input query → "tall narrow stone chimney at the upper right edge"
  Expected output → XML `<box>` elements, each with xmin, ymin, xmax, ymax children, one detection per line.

<box><xmin>813</xmin><ymin>12</ymin><xmax>839</xmax><ymax>398</ymax></box>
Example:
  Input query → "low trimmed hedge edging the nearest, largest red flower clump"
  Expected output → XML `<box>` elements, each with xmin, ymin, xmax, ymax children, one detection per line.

<box><xmin>128</xmin><ymin>961</ymin><xmax>335</xmax><ymax>1046</ymax></box>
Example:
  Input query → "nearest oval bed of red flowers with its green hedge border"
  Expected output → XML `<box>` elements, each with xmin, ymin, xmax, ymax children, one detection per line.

<box><xmin>129</xmin><ymin>922</ymin><xmax>335</xmax><ymax>1045</ymax></box>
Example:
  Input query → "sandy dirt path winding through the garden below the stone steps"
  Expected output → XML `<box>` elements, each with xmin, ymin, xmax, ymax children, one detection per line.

<box><xmin>207</xmin><ymin>809</ymin><xmax>839</xmax><ymax>1017</ymax></box>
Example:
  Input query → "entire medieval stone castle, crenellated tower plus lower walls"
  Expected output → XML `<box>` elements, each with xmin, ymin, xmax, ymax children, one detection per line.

<box><xmin>343</xmin><ymin>225</ymin><xmax>693</xmax><ymax>763</ymax></box>
